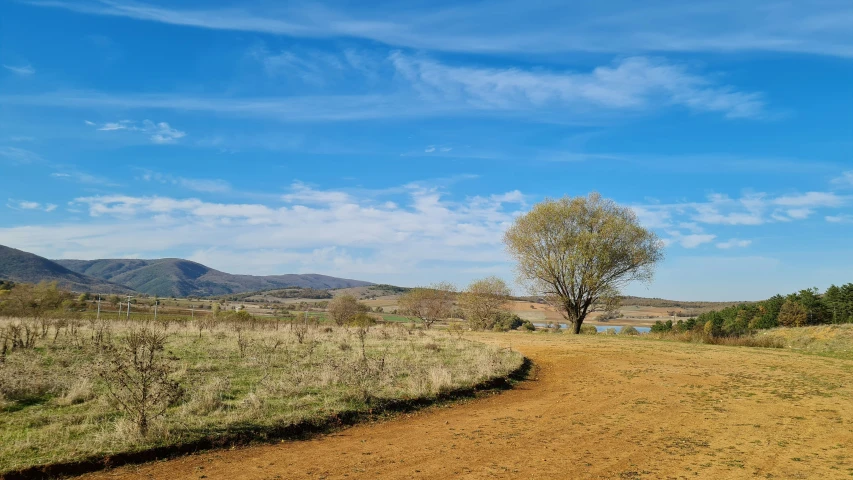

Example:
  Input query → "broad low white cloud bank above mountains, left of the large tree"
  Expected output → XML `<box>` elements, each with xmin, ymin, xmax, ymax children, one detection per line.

<box><xmin>0</xmin><ymin>184</ymin><xmax>523</xmax><ymax>280</ymax></box>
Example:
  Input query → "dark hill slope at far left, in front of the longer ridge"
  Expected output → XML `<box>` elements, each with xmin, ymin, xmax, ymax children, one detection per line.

<box><xmin>0</xmin><ymin>245</ymin><xmax>132</xmax><ymax>293</ymax></box>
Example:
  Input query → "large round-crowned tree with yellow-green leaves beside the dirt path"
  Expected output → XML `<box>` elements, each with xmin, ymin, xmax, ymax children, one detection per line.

<box><xmin>504</xmin><ymin>193</ymin><xmax>663</xmax><ymax>334</ymax></box>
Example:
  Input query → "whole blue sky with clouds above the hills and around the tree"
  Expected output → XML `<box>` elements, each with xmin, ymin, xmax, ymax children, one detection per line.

<box><xmin>0</xmin><ymin>0</ymin><xmax>853</xmax><ymax>300</ymax></box>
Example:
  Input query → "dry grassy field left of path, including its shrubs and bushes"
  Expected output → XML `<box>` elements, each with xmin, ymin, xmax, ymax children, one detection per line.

<box><xmin>0</xmin><ymin>284</ymin><xmax>522</xmax><ymax>472</ymax></box>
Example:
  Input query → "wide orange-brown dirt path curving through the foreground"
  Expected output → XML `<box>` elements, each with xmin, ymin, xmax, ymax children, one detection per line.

<box><xmin>84</xmin><ymin>334</ymin><xmax>853</xmax><ymax>479</ymax></box>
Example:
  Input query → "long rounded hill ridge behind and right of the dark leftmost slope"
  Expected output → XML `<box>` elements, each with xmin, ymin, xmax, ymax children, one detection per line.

<box><xmin>55</xmin><ymin>258</ymin><xmax>373</xmax><ymax>297</ymax></box>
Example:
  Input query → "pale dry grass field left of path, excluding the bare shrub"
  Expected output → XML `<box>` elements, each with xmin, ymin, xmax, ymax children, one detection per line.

<box><xmin>0</xmin><ymin>318</ymin><xmax>522</xmax><ymax>473</ymax></box>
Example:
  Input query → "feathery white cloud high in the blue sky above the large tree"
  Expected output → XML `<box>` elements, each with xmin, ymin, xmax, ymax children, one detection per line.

<box><xmin>390</xmin><ymin>52</ymin><xmax>764</xmax><ymax>118</ymax></box>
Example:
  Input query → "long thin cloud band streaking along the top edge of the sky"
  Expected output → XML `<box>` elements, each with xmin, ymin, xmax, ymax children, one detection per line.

<box><xmin>25</xmin><ymin>0</ymin><xmax>853</xmax><ymax>57</ymax></box>
